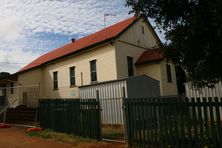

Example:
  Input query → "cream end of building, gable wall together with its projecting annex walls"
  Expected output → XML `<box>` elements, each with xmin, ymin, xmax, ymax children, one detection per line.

<box><xmin>115</xmin><ymin>19</ymin><xmax>177</xmax><ymax>96</ymax></box>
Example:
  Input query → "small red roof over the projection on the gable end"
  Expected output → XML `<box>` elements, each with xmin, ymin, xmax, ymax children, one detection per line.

<box><xmin>136</xmin><ymin>49</ymin><xmax>164</xmax><ymax>64</ymax></box>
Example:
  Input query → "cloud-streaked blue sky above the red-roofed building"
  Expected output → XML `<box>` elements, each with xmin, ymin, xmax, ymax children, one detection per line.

<box><xmin>0</xmin><ymin>0</ymin><xmax>163</xmax><ymax>73</ymax></box>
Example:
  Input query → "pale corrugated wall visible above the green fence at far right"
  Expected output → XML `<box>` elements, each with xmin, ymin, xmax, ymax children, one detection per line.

<box><xmin>185</xmin><ymin>82</ymin><xmax>222</xmax><ymax>98</ymax></box>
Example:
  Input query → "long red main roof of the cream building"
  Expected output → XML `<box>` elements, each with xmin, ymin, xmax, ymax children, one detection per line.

<box><xmin>18</xmin><ymin>16</ymin><xmax>137</xmax><ymax>73</ymax></box>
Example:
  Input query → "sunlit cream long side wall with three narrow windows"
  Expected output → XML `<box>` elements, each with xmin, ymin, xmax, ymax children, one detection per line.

<box><xmin>43</xmin><ymin>44</ymin><xmax>117</xmax><ymax>98</ymax></box>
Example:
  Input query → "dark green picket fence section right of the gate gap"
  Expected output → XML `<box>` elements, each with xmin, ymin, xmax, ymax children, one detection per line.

<box><xmin>124</xmin><ymin>98</ymin><xmax>222</xmax><ymax>148</ymax></box>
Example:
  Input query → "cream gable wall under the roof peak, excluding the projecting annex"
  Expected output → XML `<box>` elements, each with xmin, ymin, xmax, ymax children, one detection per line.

<box><xmin>115</xmin><ymin>18</ymin><xmax>158</xmax><ymax>79</ymax></box>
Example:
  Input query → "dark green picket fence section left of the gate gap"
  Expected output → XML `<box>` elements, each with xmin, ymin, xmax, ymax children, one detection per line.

<box><xmin>39</xmin><ymin>99</ymin><xmax>101</xmax><ymax>139</ymax></box>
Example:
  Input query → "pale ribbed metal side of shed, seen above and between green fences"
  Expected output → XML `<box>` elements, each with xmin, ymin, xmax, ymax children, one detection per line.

<box><xmin>79</xmin><ymin>80</ymin><xmax>127</xmax><ymax>124</ymax></box>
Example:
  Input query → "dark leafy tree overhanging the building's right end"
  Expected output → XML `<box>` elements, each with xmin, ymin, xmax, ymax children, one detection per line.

<box><xmin>127</xmin><ymin>0</ymin><xmax>222</xmax><ymax>86</ymax></box>
